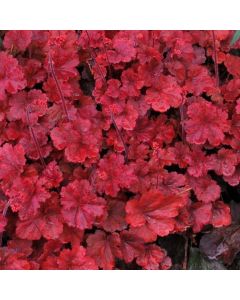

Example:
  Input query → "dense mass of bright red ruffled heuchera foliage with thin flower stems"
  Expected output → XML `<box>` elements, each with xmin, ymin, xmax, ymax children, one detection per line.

<box><xmin>0</xmin><ymin>30</ymin><xmax>240</xmax><ymax>270</ymax></box>
